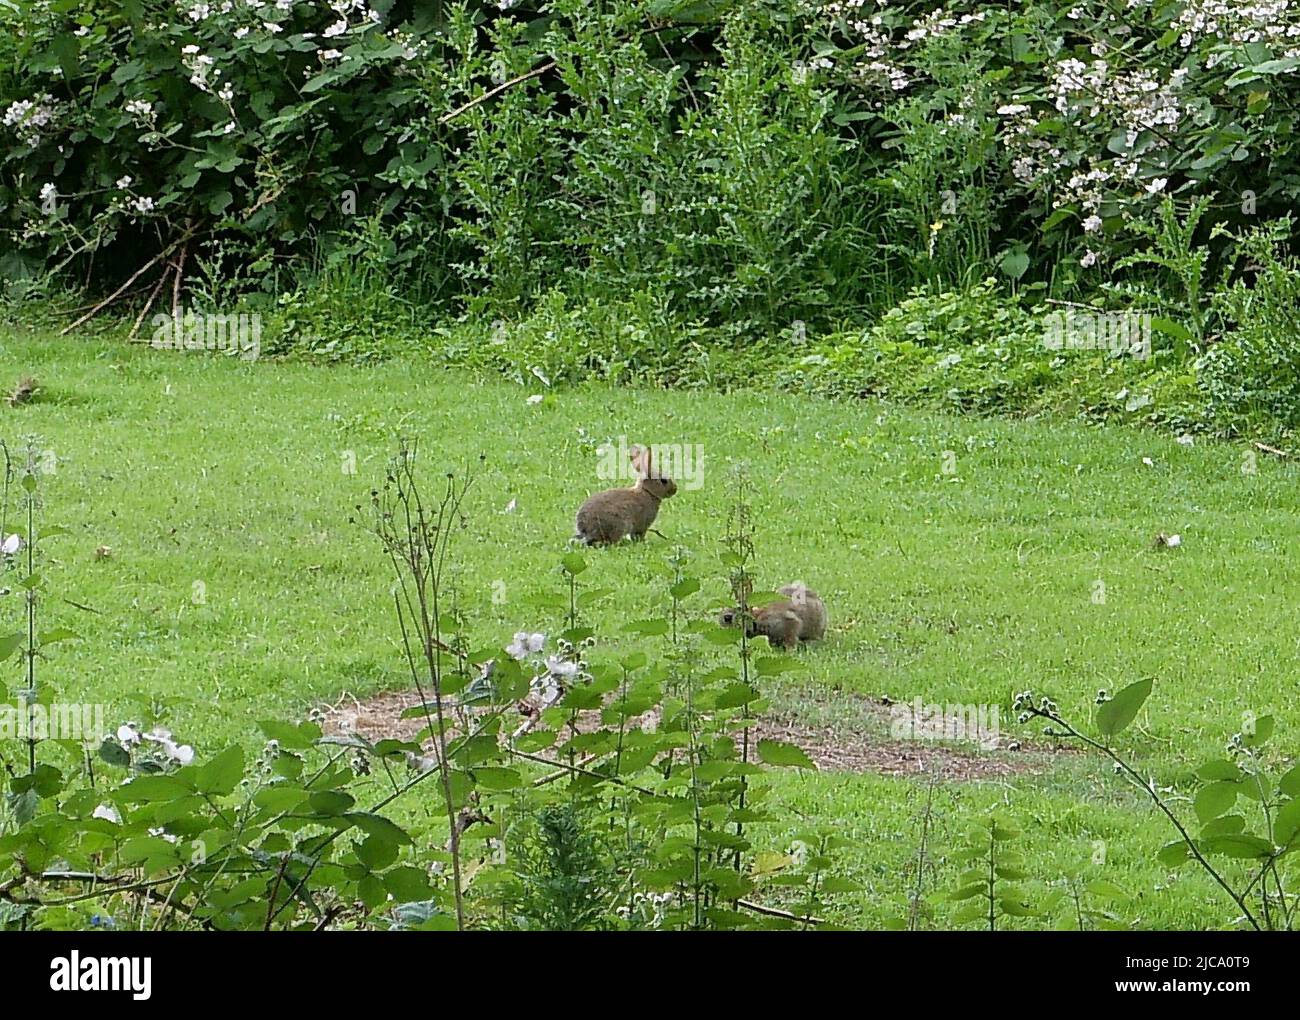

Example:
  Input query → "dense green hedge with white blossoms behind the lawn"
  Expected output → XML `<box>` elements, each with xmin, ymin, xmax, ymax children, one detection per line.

<box><xmin>0</xmin><ymin>0</ymin><xmax>1300</xmax><ymax>427</ymax></box>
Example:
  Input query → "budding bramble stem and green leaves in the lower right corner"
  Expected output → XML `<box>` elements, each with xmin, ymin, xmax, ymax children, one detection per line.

<box><xmin>1015</xmin><ymin>680</ymin><xmax>1300</xmax><ymax>930</ymax></box>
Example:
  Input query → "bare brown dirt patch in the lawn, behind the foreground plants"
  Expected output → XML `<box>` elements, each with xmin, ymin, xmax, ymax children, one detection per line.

<box><xmin>322</xmin><ymin>690</ymin><xmax>1074</xmax><ymax>782</ymax></box>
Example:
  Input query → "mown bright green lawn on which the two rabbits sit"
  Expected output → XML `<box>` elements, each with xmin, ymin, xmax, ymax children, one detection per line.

<box><xmin>0</xmin><ymin>322</ymin><xmax>1300</xmax><ymax>928</ymax></box>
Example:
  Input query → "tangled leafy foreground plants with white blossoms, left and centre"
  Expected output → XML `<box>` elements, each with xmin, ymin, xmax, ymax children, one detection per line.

<box><xmin>0</xmin><ymin>446</ymin><xmax>857</xmax><ymax>930</ymax></box>
